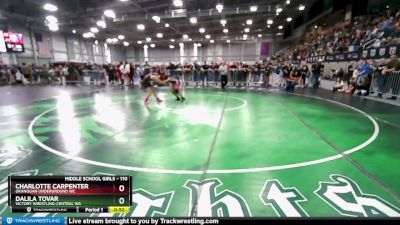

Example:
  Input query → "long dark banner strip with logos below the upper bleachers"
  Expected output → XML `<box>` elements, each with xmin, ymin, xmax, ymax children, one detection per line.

<box><xmin>306</xmin><ymin>45</ymin><xmax>400</xmax><ymax>63</ymax></box>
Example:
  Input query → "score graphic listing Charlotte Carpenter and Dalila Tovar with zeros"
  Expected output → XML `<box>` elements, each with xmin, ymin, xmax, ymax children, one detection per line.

<box><xmin>8</xmin><ymin>176</ymin><xmax>132</xmax><ymax>213</ymax></box>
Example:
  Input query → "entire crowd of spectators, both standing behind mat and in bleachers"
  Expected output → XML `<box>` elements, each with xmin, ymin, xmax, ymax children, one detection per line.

<box><xmin>0</xmin><ymin>7</ymin><xmax>400</xmax><ymax>99</ymax></box>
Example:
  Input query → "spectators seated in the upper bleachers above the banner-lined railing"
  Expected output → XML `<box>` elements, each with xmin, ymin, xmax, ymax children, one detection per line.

<box><xmin>273</xmin><ymin>7</ymin><xmax>400</xmax><ymax>61</ymax></box>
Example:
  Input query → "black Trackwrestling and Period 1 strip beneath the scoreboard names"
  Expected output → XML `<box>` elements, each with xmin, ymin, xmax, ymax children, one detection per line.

<box><xmin>11</xmin><ymin>206</ymin><xmax>109</xmax><ymax>213</ymax></box>
